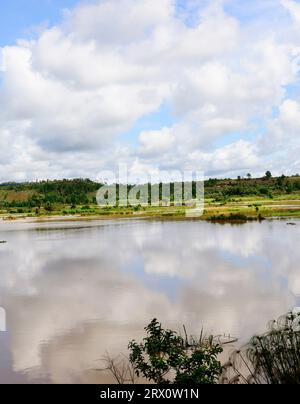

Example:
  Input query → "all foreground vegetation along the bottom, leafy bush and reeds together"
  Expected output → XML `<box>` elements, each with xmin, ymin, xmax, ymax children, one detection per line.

<box><xmin>104</xmin><ymin>313</ymin><xmax>300</xmax><ymax>385</ymax></box>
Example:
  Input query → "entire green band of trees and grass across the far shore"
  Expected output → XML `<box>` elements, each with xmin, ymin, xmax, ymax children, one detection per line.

<box><xmin>0</xmin><ymin>172</ymin><xmax>300</xmax><ymax>222</ymax></box>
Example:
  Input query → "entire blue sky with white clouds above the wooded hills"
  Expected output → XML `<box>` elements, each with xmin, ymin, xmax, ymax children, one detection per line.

<box><xmin>0</xmin><ymin>0</ymin><xmax>300</xmax><ymax>182</ymax></box>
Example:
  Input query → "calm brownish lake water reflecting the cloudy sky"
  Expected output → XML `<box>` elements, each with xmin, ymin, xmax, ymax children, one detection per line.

<box><xmin>0</xmin><ymin>221</ymin><xmax>300</xmax><ymax>383</ymax></box>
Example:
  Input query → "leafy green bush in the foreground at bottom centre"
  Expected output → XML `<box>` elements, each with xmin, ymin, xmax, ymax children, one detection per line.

<box><xmin>129</xmin><ymin>319</ymin><xmax>223</xmax><ymax>384</ymax></box>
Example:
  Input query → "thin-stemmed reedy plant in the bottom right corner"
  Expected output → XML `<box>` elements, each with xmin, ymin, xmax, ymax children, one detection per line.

<box><xmin>223</xmin><ymin>313</ymin><xmax>300</xmax><ymax>384</ymax></box>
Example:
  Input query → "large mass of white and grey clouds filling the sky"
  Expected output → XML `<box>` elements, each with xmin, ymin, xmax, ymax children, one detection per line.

<box><xmin>0</xmin><ymin>0</ymin><xmax>300</xmax><ymax>179</ymax></box>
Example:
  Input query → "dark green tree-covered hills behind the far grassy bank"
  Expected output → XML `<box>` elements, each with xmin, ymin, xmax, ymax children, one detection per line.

<box><xmin>0</xmin><ymin>171</ymin><xmax>300</xmax><ymax>208</ymax></box>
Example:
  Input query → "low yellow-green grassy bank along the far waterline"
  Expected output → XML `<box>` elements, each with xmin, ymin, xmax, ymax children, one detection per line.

<box><xmin>0</xmin><ymin>195</ymin><xmax>300</xmax><ymax>222</ymax></box>
